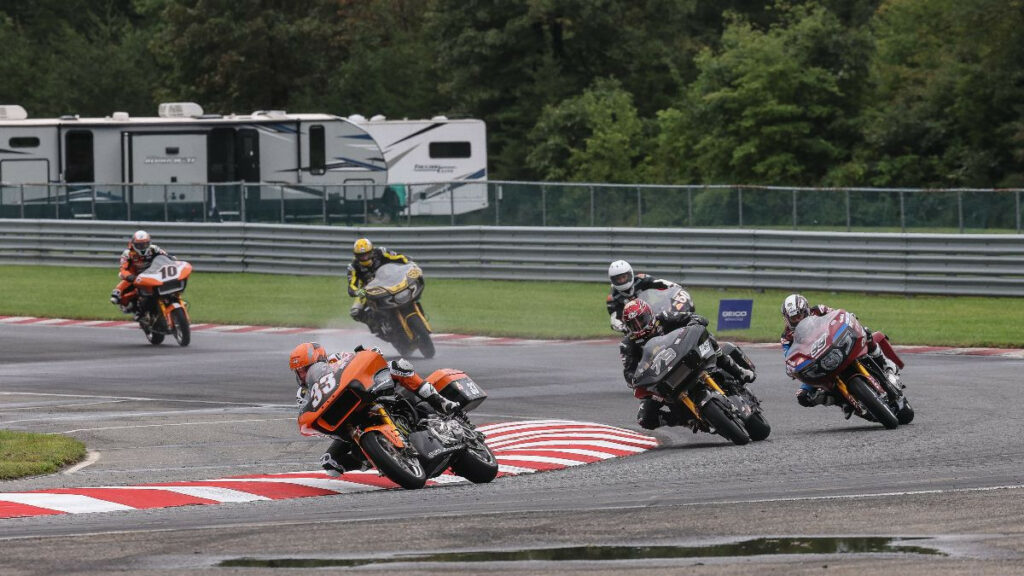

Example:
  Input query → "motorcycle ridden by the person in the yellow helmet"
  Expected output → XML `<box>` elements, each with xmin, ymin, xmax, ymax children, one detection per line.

<box><xmin>365</xmin><ymin>262</ymin><xmax>435</xmax><ymax>358</ymax></box>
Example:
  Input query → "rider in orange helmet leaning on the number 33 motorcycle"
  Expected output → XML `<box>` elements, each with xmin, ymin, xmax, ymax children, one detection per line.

<box><xmin>288</xmin><ymin>342</ymin><xmax>459</xmax><ymax>477</ymax></box>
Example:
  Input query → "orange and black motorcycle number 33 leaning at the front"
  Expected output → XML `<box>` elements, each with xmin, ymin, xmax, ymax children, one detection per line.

<box><xmin>299</xmin><ymin>351</ymin><xmax>498</xmax><ymax>490</ymax></box>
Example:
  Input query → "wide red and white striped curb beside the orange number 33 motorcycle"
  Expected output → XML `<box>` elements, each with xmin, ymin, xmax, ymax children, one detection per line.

<box><xmin>0</xmin><ymin>420</ymin><xmax>657</xmax><ymax>519</ymax></box>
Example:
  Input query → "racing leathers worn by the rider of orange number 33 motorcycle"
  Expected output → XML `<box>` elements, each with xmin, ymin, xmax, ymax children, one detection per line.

<box><xmin>295</xmin><ymin>345</ymin><xmax>459</xmax><ymax>476</ymax></box>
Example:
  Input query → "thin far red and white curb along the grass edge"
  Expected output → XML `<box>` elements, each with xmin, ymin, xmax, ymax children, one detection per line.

<box><xmin>0</xmin><ymin>316</ymin><xmax>1024</xmax><ymax>359</ymax></box>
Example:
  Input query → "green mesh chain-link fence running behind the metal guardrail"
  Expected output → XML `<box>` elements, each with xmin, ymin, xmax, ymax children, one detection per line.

<box><xmin>0</xmin><ymin>180</ymin><xmax>1024</xmax><ymax>234</ymax></box>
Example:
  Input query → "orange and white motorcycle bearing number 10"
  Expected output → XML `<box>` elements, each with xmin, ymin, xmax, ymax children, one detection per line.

<box><xmin>133</xmin><ymin>254</ymin><xmax>193</xmax><ymax>346</ymax></box>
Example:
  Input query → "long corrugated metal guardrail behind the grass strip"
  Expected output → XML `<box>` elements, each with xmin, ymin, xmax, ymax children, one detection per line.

<box><xmin>0</xmin><ymin>219</ymin><xmax>1024</xmax><ymax>296</ymax></box>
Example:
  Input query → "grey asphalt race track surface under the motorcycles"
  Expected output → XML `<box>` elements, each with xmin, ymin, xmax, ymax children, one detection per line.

<box><xmin>0</xmin><ymin>326</ymin><xmax>1024</xmax><ymax>574</ymax></box>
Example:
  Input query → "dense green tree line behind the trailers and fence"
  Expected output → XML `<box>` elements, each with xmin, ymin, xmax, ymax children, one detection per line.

<box><xmin>0</xmin><ymin>0</ymin><xmax>1024</xmax><ymax>188</ymax></box>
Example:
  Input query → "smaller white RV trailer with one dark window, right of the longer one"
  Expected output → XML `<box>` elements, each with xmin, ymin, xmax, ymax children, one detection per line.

<box><xmin>348</xmin><ymin>115</ymin><xmax>487</xmax><ymax>215</ymax></box>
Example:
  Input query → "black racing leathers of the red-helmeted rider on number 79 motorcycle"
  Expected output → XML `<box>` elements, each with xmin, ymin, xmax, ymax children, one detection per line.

<box><xmin>618</xmin><ymin>312</ymin><xmax>755</xmax><ymax>429</ymax></box>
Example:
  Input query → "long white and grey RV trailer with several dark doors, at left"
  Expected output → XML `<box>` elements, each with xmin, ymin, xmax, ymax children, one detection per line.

<box><xmin>0</xmin><ymin>102</ymin><xmax>387</xmax><ymax>218</ymax></box>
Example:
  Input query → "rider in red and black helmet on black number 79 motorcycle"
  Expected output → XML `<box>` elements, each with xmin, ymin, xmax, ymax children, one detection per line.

<box><xmin>618</xmin><ymin>298</ymin><xmax>757</xmax><ymax>429</ymax></box>
